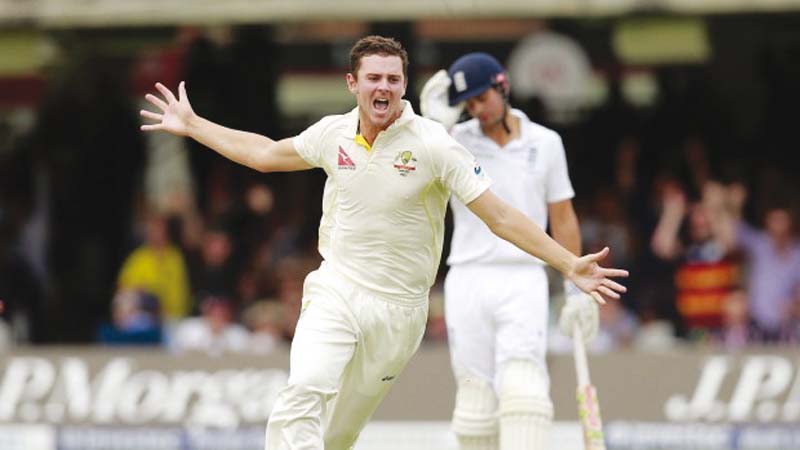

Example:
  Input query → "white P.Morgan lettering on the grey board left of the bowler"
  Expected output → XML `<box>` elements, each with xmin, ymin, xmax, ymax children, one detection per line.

<box><xmin>0</xmin><ymin>356</ymin><xmax>288</xmax><ymax>427</ymax></box>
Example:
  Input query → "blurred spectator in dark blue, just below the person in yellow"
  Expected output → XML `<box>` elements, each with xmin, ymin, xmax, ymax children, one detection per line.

<box><xmin>98</xmin><ymin>289</ymin><xmax>162</xmax><ymax>345</ymax></box>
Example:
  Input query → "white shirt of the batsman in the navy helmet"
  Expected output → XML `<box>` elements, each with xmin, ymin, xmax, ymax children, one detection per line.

<box><xmin>447</xmin><ymin>109</ymin><xmax>575</xmax><ymax>266</ymax></box>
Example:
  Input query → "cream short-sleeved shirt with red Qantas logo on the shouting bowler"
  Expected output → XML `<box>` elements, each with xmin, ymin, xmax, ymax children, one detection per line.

<box><xmin>293</xmin><ymin>101</ymin><xmax>491</xmax><ymax>299</ymax></box>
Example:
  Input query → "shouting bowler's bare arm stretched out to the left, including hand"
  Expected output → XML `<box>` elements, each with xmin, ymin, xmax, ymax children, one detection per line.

<box><xmin>139</xmin><ymin>81</ymin><xmax>311</xmax><ymax>172</ymax></box>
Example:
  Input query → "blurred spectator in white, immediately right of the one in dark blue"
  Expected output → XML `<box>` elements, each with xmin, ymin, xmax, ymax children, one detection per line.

<box><xmin>170</xmin><ymin>296</ymin><xmax>250</xmax><ymax>356</ymax></box>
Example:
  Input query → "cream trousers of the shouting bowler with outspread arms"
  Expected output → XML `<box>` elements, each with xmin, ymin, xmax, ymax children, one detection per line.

<box><xmin>265</xmin><ymin>262</ymin><xmax>428</xmax><ymax>450</ymax></box>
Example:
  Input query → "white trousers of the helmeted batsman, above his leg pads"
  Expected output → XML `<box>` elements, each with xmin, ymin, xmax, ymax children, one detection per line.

<box><xmin>444</xmin><ymin>264</ymin><xmax>549</xmax><ymax>389</ymax></box>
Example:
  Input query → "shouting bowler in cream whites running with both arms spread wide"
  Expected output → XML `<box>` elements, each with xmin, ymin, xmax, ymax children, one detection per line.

<box><xmin>141</xmin><ymin>36</ymin><xmax>627</xmax><ymax>450</ymax></box>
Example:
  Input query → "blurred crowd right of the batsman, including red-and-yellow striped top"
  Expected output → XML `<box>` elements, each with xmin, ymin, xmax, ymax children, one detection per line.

<box><xmin>553</xmin><ymin>136</ymin><xmax>800</xmax><ymax>351</ymax></box>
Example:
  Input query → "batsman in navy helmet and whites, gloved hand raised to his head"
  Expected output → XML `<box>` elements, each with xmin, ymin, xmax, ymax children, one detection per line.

<box><xmin>421</xmin><ymin>53</ymin><xmax>598</xmax><ymax>450</ymax></box>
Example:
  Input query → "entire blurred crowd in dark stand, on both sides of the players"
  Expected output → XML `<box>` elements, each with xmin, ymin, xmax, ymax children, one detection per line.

<box><xmin>0</xmin><ymin>30</ymin><xmax>800</xmax><ymax>355</ymax></box>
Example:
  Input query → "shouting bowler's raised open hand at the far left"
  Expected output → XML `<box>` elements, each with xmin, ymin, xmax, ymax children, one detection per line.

<box><xmin>139</xmin><ymin>81</ymin><xmax>196</xmax><ymax>136</ymax></box>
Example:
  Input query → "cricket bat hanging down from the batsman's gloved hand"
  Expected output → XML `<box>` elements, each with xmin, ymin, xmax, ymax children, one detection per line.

<box><xmin>572</xmin><ymin>323</ymin><xmax>606</xmax><ymax>450</ymax></box>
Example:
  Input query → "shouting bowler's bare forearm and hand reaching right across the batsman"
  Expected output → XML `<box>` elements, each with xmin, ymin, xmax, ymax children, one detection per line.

<box><xmin>467</xmin><ymin>189</ymin><xmax>628</xmax><ymax>303</ymax></box>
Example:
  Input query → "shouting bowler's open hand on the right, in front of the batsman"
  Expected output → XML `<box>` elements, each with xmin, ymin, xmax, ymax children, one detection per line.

<box><xmin>567</xmin><ymin>247</ymin><xmax>628</xmax><ymax>305</ymax></box>
